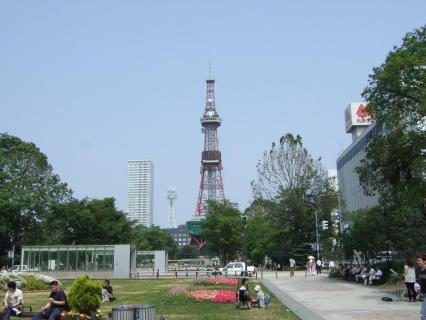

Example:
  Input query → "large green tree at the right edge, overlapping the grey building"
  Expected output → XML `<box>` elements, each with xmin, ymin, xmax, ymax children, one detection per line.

<box><xmin>357</xmin><ymin>26</ymin><xmax>426</xmax><ymax>218</ymax></box>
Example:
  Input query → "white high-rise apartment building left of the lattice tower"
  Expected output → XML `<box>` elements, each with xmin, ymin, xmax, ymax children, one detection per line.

<box><xmin>127</xmin><ymin>160</ymin><xmax>154</xmax><ymax>227</ymax></box>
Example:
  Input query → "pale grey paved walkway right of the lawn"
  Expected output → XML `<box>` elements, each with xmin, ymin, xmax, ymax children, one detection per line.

<box><xmin>262</xmin><ymin>272</ymin><xmax>421</xmax><ymax>320</ymax></box>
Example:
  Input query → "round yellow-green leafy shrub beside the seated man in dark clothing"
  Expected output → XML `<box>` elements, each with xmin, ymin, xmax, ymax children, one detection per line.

<box><xmin>68</xmin><ymin>275</ymin><xmax>102</xmax><ymax>315</ymax></box>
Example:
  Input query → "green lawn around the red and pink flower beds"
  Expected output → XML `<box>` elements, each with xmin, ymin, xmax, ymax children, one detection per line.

<box><xmin>24</xmin><ymin>280</ymin><xmax>299</xmax><ymax>320</ymax></box>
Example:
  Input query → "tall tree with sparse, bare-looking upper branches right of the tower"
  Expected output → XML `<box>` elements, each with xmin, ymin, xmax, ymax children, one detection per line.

<box><xmin>249</xmin><ymin>134</ymin><xmax>337</xmax><ymax>263</ymax></box>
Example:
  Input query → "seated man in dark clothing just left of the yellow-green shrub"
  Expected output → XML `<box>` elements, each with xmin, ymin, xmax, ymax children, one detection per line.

<box><xmin>32</xmin><ymin>280</ymin><xmax>67</xmax><ymax>320</ymax></box>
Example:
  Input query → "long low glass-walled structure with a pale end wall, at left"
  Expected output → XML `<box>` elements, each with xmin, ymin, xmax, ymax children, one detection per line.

<box><xmin>21</xmin><ymin>245</ymin><xmax>136</xmax><ymax>278</ymax></box>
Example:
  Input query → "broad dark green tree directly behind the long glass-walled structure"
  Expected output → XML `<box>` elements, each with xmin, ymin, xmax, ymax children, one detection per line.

<box><xmin>44</xmin><ymin>198</ymin><xmax>133</xmax><ymax>244</ymax></box>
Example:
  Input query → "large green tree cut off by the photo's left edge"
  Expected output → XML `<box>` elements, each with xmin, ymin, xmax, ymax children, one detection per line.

<box><xmin>0</xmin><ymin>134</ymin><xmax>71</xmax><ymax>262</ymax></box>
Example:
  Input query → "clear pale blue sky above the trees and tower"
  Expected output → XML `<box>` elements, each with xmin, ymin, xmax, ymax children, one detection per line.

<box><xmin>0</xmin><ymin>0</ymin><xmax>426</xmax><ymax>226</ymax></box>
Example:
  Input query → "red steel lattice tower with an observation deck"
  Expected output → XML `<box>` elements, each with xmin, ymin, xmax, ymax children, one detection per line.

<box><xmin>195</xmin><ymin>80</ymin><xmax>225</xmax><ymax>217</ymax></box>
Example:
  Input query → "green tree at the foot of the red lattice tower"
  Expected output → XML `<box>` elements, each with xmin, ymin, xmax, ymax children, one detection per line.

<box><xmin>202</xmin><ymin>200</ymin><xmax>243</xmax><ymax>264</ymax></box>
